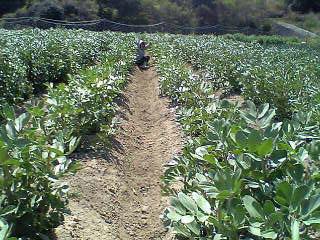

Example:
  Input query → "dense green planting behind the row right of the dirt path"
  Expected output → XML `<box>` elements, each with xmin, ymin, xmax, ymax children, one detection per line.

<box><xmin>152</xmin><ymin>35</ymin><xmax>320</xmax><ymax>119</ymax></box>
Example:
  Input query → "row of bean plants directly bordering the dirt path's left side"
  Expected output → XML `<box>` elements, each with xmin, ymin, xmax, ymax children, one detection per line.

<box><xmin>0</xmin><ymin>32</ymin><xmax>135</xmax><ymax>239</ymax></box>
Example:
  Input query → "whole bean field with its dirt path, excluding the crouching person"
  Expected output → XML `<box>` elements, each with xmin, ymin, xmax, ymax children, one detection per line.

<box><xmin>0</xmin><ymin>29</ymin><xmax>320</xmax><ymax>240</ymax></box>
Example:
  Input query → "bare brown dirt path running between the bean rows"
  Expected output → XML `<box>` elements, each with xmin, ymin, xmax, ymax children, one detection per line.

<box><xmin>56</xmin><ymin>68</ymin><xmax>182</xmax><ymax>240</ymax></box>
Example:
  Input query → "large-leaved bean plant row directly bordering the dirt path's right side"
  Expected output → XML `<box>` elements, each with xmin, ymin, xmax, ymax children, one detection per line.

<box><xmin>152</xmin><ymin>36</ymin><xmax>320</xmax><ymax>240</ymax></box>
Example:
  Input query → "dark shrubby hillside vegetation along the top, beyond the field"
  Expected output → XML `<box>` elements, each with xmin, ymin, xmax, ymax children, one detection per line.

<box><xmin>0</xmin><ymin>0</ymin><xmax>320</xmax><ymax>30</ymax></box>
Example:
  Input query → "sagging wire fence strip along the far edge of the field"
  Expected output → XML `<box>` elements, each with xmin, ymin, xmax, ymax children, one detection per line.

<box><xmin>0</xmin><ymin>17</ymin><xmax>264</xmax><ymax>35</ymax></box>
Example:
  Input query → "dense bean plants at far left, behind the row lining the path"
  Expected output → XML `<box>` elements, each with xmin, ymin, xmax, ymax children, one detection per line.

<box><xmin>0</xmin><ymin>29</ymin><xmax>116</xmax><ymax>112</ymax></box>
